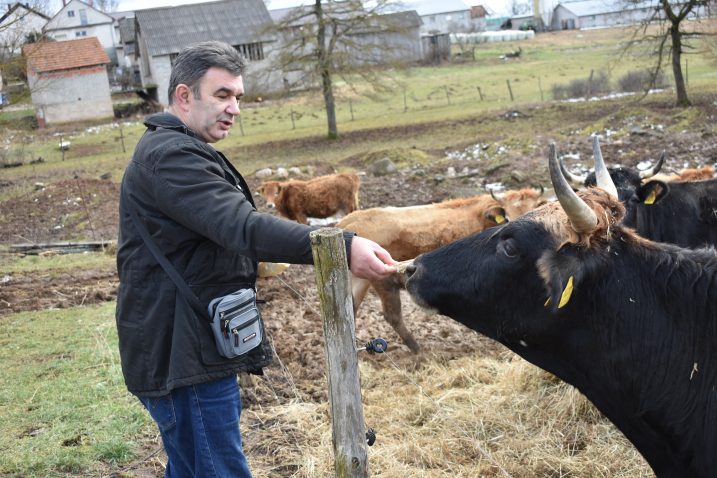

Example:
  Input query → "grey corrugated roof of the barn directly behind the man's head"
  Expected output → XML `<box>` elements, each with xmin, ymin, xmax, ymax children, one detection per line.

<box><xmin>135</xmin><ymin>0</ymin><xmax>273</xmax><ymax>56</ymax></box>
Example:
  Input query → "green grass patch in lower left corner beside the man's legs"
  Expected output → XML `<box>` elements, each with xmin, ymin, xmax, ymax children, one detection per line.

<box><xmin>0</xmin><ymin>303</ymin><xmax>154</xmax><ymax>477</ymax></box>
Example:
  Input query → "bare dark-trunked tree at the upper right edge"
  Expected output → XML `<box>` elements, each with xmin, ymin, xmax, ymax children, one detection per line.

<box><xmin>627</xmin><ymin>0</ymin><xmax>717</xmax><ymax>106</ymax></box>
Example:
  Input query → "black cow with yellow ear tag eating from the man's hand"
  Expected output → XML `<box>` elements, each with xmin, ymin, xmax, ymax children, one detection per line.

<box><xmin>406</xmin><ymin>145</ymin><xmax>717</xmax><ymax>478</ymax></box>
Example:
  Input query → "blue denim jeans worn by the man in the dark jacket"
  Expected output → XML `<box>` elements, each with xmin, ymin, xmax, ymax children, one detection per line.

<box><xmin>138</xmin><ymin>375</ymin><xmax>251</xmax><ymax>478</ymax></box>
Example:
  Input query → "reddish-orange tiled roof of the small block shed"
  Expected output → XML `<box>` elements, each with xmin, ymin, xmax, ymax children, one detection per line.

<box><xmin>22</xmin><ymin>37</ymin><xmax>110</xmax><ymax>73</ymax></box>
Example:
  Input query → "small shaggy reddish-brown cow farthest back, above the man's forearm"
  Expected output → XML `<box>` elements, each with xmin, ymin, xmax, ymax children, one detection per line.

<box><xmin>257</xmin><ymin>173</ymin><xmax>360</xmax><ymax>224</ymax></box>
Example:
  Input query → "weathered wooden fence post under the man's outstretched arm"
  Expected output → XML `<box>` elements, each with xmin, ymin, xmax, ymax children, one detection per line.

<box><xmin>310</xmin><ymin>227</ymin><xmax>368</xmax><ymax>478</ymax></box>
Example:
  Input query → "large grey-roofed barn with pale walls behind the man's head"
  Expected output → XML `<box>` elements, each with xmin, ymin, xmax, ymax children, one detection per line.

<box><xmin>135</xmin><ymin>0</ymin><xmax>283</xmax><ymax>105</ymax></box>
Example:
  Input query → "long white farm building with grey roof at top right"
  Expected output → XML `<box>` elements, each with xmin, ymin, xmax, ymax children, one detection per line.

<box><xmin>550</xmin><ymin>0</ymin><xmax>655</xmax><ymax>30</ymax></box>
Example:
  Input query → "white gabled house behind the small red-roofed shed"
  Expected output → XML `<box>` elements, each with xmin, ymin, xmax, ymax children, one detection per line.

<box><xmin>43</xmin><ymin>0</ymin><xmax>117</xmax><ymax>65</ymax></box>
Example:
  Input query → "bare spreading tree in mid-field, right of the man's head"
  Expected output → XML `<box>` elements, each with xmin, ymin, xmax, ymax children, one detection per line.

<box><xmin>264</xmin><ymin>0</ymin><xmax>420</xmax><ymax>139</ymax></box>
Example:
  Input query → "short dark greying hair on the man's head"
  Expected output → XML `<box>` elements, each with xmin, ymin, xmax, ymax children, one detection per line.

<box><xmin>168</xmin><ymin>41</ymin><xmax>246</xmax><ymax>105</ymax></box>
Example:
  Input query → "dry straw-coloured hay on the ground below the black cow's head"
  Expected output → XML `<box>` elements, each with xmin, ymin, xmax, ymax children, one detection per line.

<box><xmin>242</xmin><ymin>344</ymin><xmax>653</xmax><ymax>478</ymax></box>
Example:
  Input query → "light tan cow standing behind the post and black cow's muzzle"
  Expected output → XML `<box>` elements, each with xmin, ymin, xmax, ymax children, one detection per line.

<box><xmin>337</xmin><ymin>190</ymin><xmax>539</xmax><ymax>352</ymax></box>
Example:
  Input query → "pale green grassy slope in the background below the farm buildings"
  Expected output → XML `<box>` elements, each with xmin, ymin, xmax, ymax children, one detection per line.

<box><xmin>0</xmin><ymin>21</ymin><xmax>717</xmax><ymax>181</ymax></box>
